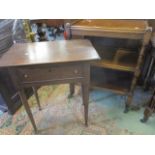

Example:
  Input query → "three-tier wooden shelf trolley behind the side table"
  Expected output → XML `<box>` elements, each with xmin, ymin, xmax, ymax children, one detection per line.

<box><xmin>65</xmin><ymin>19</ymin><xmax>152</xmax><ymax>112</ymax></box>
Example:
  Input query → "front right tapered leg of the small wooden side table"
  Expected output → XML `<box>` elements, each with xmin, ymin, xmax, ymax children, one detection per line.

<box><xmin>82</xmin><ymin>84</ymin><xmax>89</xmax><ymax>126</ymax></box>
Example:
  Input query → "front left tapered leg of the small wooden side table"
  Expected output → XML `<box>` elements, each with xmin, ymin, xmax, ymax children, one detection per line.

<box><xmin>19</xmin><ymin>88</ymin><xmax>37</xmax><ymax>132</ymax></box>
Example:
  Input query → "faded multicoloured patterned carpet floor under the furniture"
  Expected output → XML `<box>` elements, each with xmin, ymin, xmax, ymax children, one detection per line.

<box><xmin>0</xmin><ymin>85</ymin><xmax>155</xmax><ymax>135</ymax></box>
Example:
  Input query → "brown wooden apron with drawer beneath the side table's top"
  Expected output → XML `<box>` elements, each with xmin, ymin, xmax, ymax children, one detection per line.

<box><xmin>9</xmin><ymin>63</ymin><xmax>90</xmax><ymax>89</ymax></box>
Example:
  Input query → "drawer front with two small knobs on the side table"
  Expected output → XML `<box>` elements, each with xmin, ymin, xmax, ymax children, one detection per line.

<box><xmin>16</xmin><ymin>65</ymin><xmax>84</xmax><ymax>83</ymax></box>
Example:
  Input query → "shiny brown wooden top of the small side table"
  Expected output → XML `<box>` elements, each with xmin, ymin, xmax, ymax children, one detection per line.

<box><xmin>0</xmin><ymin>39</ymin><xmax>99</xmax><ymax>67</ymax></box>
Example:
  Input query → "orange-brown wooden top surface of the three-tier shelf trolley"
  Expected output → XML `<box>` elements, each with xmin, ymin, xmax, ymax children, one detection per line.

<box><xmin>71</xmin><ymin>19</ymin><xmax>149</xmax><ymax>33</ymax></box>
